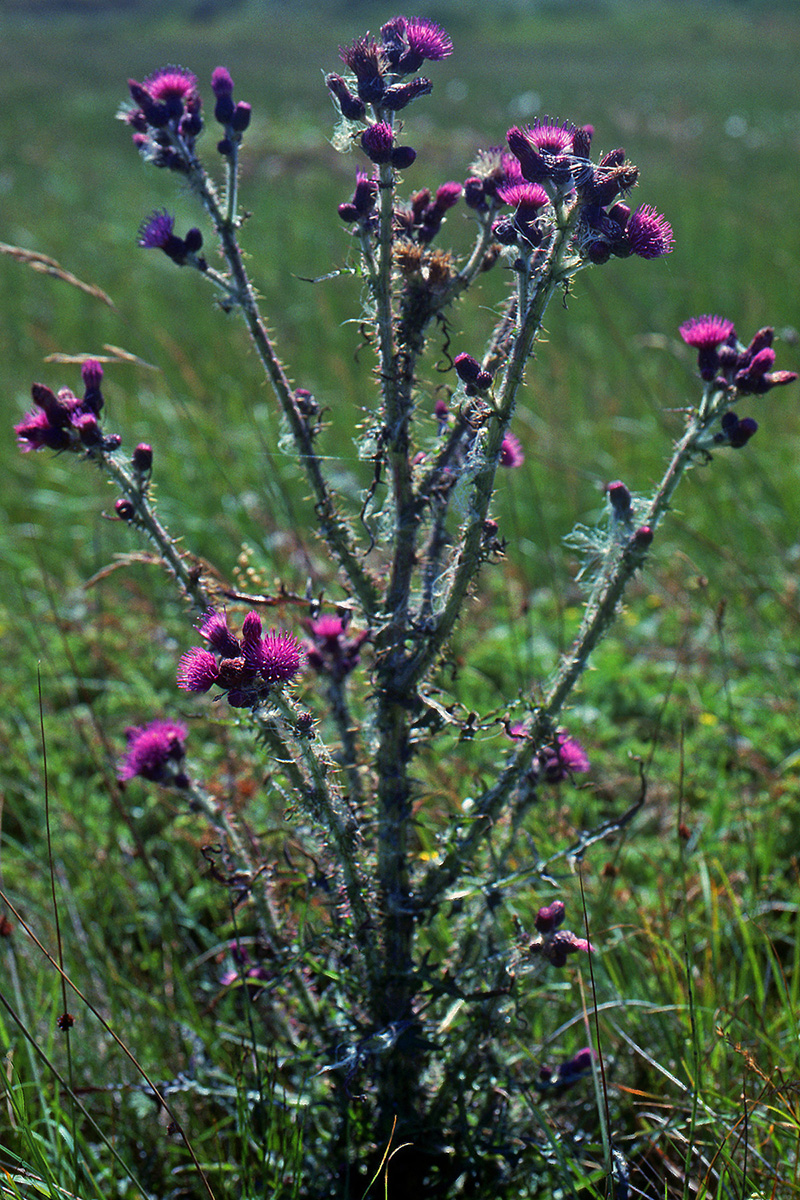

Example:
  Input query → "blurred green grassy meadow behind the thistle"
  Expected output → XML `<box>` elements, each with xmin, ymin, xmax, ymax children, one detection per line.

<box><xmin>0</xmin><ymin>0</ymin><xmax>800</xmax><ymax>1196</ymax></box>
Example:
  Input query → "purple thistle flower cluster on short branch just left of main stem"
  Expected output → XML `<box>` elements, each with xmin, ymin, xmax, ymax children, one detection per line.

<box><xmin>178</xmin><ymin>608</ymin><xmax>302</xmax><ymax>708</ymax></box>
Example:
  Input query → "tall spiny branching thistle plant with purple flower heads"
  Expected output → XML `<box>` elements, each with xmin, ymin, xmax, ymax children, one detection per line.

<box><xmin>9</xmin><ymin>17</ymin><xmax>795</xmax><ymax>1198</ymax></box>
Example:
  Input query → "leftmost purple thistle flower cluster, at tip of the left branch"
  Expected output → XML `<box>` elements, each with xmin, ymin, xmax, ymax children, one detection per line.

<box><xmin>14</xmin><ymin>359</ymin><xmax>121</xmax><ymax>452</ymax></box>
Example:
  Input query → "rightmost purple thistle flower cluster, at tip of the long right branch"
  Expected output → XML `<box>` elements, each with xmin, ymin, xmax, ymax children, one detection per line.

<box><xmin>679</xmin><ymin>313</ymin><xmax>798</xmax><ymax>450</ymax></box>
